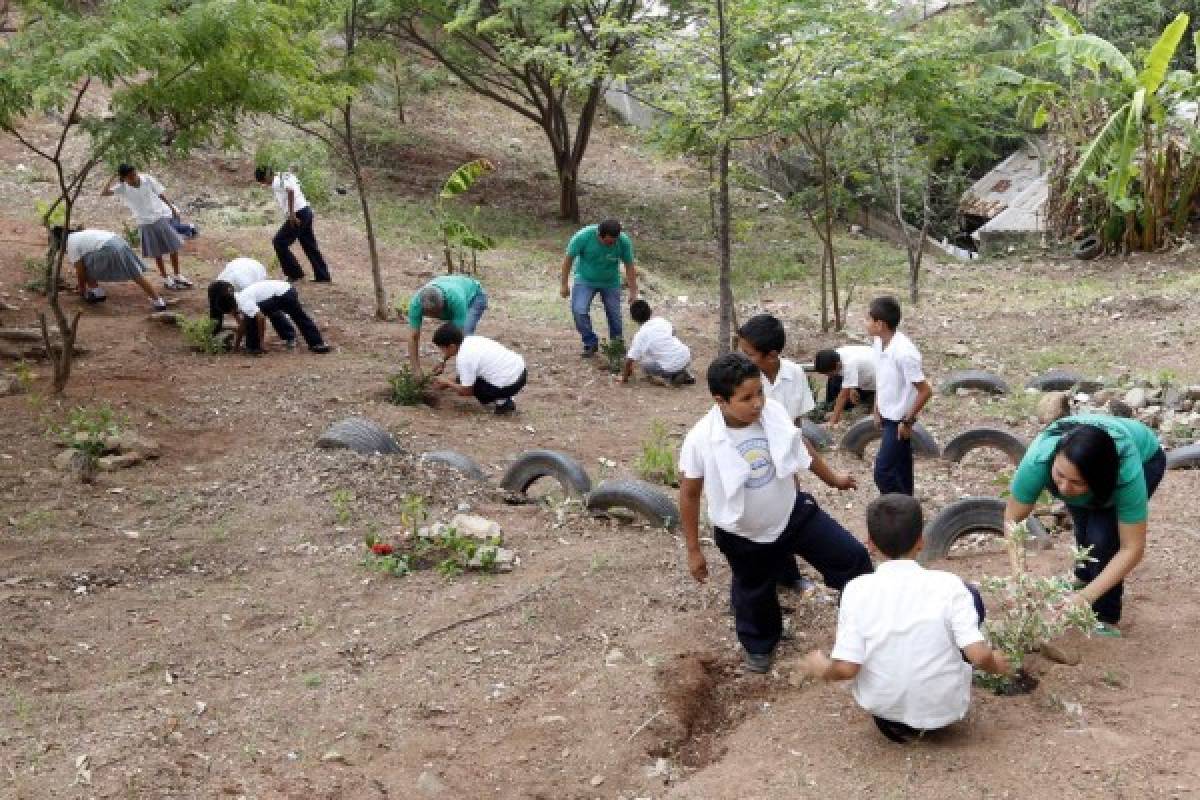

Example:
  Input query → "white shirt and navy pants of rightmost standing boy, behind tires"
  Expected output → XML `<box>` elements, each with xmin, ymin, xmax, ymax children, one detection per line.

<box><xmin>874</xmin><ymin>331</ymin><xmax>925</xmax><ymax>497</ymax></box>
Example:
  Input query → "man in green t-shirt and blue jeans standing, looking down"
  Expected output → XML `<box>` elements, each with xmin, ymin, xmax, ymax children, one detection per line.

<box><xmin>560</xmin><ymin>219</ymin><xmax>637</xmax><ymax>359</ymax></box>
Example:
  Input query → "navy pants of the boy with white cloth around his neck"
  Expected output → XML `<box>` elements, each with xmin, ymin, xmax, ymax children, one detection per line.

<box><xmin>714</xmin><ymin>492</ymin><xmax>874</xmax><ymax>654</ymax></box>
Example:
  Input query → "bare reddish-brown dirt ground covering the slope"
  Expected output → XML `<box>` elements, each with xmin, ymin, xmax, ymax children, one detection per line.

<box><xmin>0</xmin><ymin>90</ymin><xmax>1200</xmax><ymax>800</ymax></box>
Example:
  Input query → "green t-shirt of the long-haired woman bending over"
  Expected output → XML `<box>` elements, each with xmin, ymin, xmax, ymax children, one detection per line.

<box><xmin>1013</xmin><ymin>414</ymin><xmax>1160</xmax><ymax>524</ymax></box>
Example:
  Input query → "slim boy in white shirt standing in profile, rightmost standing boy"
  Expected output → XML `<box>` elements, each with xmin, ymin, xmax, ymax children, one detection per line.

<box><xmin>866</xmin><ymin>295</ymin><xmax>934</xmax><ymax>494</ymax></box>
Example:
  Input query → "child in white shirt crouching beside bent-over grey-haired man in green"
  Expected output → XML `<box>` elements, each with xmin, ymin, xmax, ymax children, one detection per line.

<box><xmin>433</xmin><ymin>323</ymin><xmax>529</xmax><ymax>414</ymax></box>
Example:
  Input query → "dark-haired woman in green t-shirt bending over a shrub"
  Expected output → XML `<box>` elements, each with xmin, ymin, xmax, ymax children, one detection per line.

<box><xmin>1004</xmin><ymin>414</ymin><xmax>1166</xmax><ymax>636</ymax></box>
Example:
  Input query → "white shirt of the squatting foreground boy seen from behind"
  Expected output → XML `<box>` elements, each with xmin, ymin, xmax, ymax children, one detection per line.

<box><xmin>829</xmin><ymin>560</ymin><xmax>983</xmax><ymax>729</ymax></box>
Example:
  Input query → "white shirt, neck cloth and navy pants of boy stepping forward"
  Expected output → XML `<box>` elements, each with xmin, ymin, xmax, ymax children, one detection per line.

<box><xmin>679</xmin><ymin>399</ymin><xmax>871</xmax><ymax>655</ymax></box>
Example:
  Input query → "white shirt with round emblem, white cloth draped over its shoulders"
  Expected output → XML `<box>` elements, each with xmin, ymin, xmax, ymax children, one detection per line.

<box><xmin>679</xmin><ymin>399</ymin><xmax>812</xmax><ymax>542</ymax></box>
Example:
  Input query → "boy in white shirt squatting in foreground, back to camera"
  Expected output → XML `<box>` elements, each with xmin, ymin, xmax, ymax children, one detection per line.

<box><xmin>802</xmin><ymin>494</ymin><xmax>1010</xmax><ymax>744</ymax></box>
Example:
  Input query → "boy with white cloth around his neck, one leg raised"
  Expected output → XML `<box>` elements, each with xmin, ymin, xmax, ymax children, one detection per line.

<box><xmin>679</xmin><ymin>353</ymin><xmax>871</xmax><ymax>673</ymax></box>
